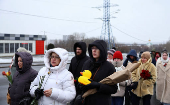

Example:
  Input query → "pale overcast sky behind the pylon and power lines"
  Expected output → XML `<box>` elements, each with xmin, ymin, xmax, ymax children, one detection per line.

<box><xmin>0</xmin><ymin>0</ymin><xmax>170</xmax><ymax>43</ymax></box>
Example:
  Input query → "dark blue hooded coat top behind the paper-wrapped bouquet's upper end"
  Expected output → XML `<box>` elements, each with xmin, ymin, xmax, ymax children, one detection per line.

<box><xmin>123</xmin><ymin>49</ymin><xmax>138</xmax><ymax>67</ymax></box>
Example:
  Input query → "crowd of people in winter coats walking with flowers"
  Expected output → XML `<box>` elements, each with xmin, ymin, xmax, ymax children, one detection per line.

<box><xmin>4</xmin><ymin>40</ymin><xmax>170</xmax><ymax>105</ymax></box>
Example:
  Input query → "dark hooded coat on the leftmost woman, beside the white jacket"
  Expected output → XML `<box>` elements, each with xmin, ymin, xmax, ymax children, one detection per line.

<box><xmin>9</xmin><ymin>52</ymin><xmax>38</xmax><ymax>105</ymax></box>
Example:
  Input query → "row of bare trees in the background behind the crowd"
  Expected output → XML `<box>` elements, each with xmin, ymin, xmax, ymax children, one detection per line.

<box><xmin>54</xmin><ymin>32</ymin><xmax>170</xmax><ymax>53</ymax></box>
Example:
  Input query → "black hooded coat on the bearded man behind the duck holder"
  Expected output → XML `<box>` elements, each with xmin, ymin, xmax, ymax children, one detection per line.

<box><xmin>69</xmin><ymin>42</ymin><xmax>89</xmax><ymax>94</ymax></box>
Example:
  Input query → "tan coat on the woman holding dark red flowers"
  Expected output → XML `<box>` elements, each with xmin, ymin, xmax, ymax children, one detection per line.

<box><xmin>132</xmin><ymin>58</ymin><xmax>157</xmax><ymax>97</ymax></box>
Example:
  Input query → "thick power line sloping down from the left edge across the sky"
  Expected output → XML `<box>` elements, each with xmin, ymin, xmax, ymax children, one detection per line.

<box><xmin>0</xmin><ymin>9</ymin><xmax>96</xmax><ymax>23</ymax></box>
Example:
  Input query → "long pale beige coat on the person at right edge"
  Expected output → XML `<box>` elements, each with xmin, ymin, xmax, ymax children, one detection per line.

<box><xmin>156</xmin><ymin>60</ymin><xmax>170</xmax><ymax>103</ymax></box>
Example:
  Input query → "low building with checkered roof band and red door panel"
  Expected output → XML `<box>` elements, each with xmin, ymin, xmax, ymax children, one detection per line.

<box><xmin>0</xmin><ymin>33</ymin><xmax>46</xmax><ymax>56</ymax></box>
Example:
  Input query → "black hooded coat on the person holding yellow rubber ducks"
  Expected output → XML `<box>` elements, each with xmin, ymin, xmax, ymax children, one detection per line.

<box><xmin>80</xmin><ymin>40</ymin><xmax>117</xmax><ymax>105</ymax></box>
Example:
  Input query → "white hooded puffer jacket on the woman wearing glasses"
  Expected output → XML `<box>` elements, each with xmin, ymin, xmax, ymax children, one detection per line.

<box><xmin>30</xmin><ymin>48</ymin><xmax>76</xmax><ymax>105</ymax></box>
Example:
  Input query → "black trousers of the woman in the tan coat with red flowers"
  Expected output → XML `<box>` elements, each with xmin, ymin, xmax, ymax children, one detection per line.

<box><xmin>131</xmin><ymin>92</ymin><xmax>152</xmax><ymax>105</ymax></box>
